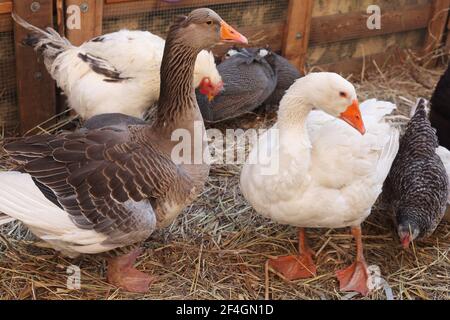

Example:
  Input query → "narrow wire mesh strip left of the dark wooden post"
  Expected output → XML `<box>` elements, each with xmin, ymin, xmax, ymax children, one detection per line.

<box><xmin>0</xmin><ymin>31</ymin><xmax>19</xmax><ymax>137</ymax></box>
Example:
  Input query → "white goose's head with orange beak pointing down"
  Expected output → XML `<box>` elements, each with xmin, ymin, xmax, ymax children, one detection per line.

<box><xmin>280</xmin><ymin>72</ymin><xmax>366</xmax><ymax>134</ymax></box>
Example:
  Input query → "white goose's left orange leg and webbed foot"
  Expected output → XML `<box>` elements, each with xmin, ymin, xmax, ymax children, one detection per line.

<box><xmin>269</xmin><ymin>228</ymin><xmax>316</xmax><ymax>280</ymax></box>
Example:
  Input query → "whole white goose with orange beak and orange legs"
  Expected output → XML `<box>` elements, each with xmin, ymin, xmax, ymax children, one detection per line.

<box><xmin>241</xmin><ymin>73</ymin><xmax>398</xmax><ymax>294</ymax></box>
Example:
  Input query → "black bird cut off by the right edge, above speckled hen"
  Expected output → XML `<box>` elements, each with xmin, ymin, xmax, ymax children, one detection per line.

<box><xmin>430</xmin><ymin>65</ymin><xmax>450</xmax><ymax>149</ymax></box>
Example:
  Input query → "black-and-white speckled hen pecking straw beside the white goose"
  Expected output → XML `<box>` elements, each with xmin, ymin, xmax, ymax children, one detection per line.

<box><xmin>383</xmin><ymin>99</ymin><xmax>449</xmax><ymax>248</ymax></box>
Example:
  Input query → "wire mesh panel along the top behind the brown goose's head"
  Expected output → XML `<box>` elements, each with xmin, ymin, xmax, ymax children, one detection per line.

<box><xmin>103</xmin><ymin>0</ymin><xmax>289</xmax><ymax>37</ymax></box>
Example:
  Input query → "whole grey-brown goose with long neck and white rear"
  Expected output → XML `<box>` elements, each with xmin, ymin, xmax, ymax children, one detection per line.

<box><xmin>0</xmin><ymin>9</ymin><xmax>247</xmax><ymax>292</ymax></box>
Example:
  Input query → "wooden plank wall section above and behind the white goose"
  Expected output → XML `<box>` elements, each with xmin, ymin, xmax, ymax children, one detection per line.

<box><xmin>308</xmin><ymin>0</ymin><xmax>448</xmax><ymax>74</ymax></box>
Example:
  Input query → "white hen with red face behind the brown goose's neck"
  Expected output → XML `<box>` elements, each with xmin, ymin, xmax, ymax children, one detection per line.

<box><xmin>12</xmin><ymin>14</ymin><xmax>223</xmax><ymax>119</ymax></box>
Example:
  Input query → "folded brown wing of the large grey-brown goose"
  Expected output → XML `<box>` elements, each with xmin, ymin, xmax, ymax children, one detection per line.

<box><xmin>5</xmin><ymin>128</ymin><xmax>192</xmax><ymax>241</ymax></box>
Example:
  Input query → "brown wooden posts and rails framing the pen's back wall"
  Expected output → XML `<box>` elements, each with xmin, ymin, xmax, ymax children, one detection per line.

<box><xmin>5</xmin><ymin>0</ymin><xmax>450</xmax><ymax>132</ymax></box>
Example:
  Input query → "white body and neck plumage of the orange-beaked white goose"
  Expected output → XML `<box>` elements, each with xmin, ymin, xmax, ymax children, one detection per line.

<box><xmin>241</xmin><ymin>76</ymin><xmax>399</xmax><ymax>228</ymax></box>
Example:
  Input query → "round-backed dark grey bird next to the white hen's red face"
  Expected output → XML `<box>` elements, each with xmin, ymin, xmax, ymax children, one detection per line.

<box><xmin>197</xmin><ymin>49</ymin><xmax>277</xmax><ymax>122</ymax></box>
